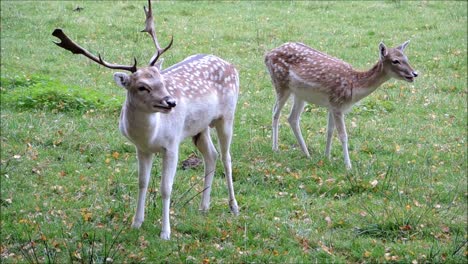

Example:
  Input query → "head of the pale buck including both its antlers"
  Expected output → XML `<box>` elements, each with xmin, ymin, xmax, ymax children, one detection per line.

<box><xmin>52</xmin><ymin>0</ymin><xmax>176</xmax><ymax>113</ymax></box>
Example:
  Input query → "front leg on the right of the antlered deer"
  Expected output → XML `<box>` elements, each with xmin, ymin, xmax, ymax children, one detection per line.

<box><xmin>161</xmin><ymin>148</ymin><xmax>179</xmax><ymax>240</ymax></box>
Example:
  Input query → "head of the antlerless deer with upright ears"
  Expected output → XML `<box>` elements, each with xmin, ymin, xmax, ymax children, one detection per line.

<box><xmin>379</xmin><ymin>40</ymin><xmax>418</xmax><ymax>82</ymax></box>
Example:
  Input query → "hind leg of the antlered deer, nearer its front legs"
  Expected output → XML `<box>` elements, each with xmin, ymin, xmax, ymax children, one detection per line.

<box><xmin>193</xmin><ymin>128</ymin><xmax>218</xmax><ymax>212</ymax></box>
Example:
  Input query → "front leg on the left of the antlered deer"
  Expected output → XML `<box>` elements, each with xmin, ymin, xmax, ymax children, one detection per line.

<box><xmin>132</xmin><ymin>150</ymin><xmax>153</xmax><ymax>228</ymax></box>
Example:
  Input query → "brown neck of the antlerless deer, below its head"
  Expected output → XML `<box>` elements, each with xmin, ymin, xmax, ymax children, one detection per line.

<box><xmin>353</xmin><ymin>61</ymin><xmax>390</xmax><ymax>102</ymax></box>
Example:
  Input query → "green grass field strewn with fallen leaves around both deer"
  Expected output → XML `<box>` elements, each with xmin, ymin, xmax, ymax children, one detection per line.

<box><xmin>0</xmin><ymin>1</ymin><xmax>468</xmax><ymax>263</ymax></box>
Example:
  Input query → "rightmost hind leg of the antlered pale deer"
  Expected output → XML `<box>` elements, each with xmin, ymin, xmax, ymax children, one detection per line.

<box><xmin>216</xmin><ymin>117</ymin><xmax>239</xmax><ymax>215</ymax></box>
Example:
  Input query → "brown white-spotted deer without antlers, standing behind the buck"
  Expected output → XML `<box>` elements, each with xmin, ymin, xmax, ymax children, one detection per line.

<box><xmin>265</xmin><ymin>41</ymin><xmax>418</xmax><ymax>169</ymax></box>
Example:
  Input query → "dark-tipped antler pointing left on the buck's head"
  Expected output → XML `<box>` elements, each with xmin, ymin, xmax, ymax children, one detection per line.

<box><xmin>52</xmin><ymin>28</ymin><xmax>137</xmax><ymax>73</ymax></box>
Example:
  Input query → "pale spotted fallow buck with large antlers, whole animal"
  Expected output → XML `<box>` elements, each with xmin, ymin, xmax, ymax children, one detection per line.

<box><xmin>53</xmin><ymin>0</ymin><xmax>239</xmax><ymax>240</ymax></box>
